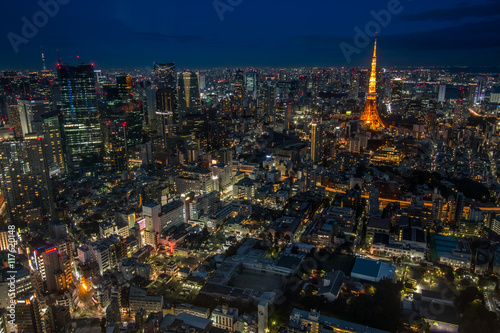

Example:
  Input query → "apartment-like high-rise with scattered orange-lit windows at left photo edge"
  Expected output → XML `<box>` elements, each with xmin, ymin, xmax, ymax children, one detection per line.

<box><xmin>0</xmin><ymin>136</ymin><xmax>53</xmax><ymax>228</ymax></box>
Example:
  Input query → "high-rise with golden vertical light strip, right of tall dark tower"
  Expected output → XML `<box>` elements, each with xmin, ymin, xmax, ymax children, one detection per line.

<box><xmin>178</xmin><ymin>72</ymin><xmax>201</xmax><ymax>120</ymax></box>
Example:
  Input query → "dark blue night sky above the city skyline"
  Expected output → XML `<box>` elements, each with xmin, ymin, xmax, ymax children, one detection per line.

<box><xmin>0</xmin><ymin>0</ymin><xmax>500</xmax><ymax>69</ymax></box>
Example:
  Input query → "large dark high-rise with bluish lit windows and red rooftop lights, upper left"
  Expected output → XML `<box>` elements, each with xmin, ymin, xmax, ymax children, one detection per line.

<box><xmin>58</xmin><ymin>64</ymin><xmax>102</xmax><ymax>174</ymax></box>
